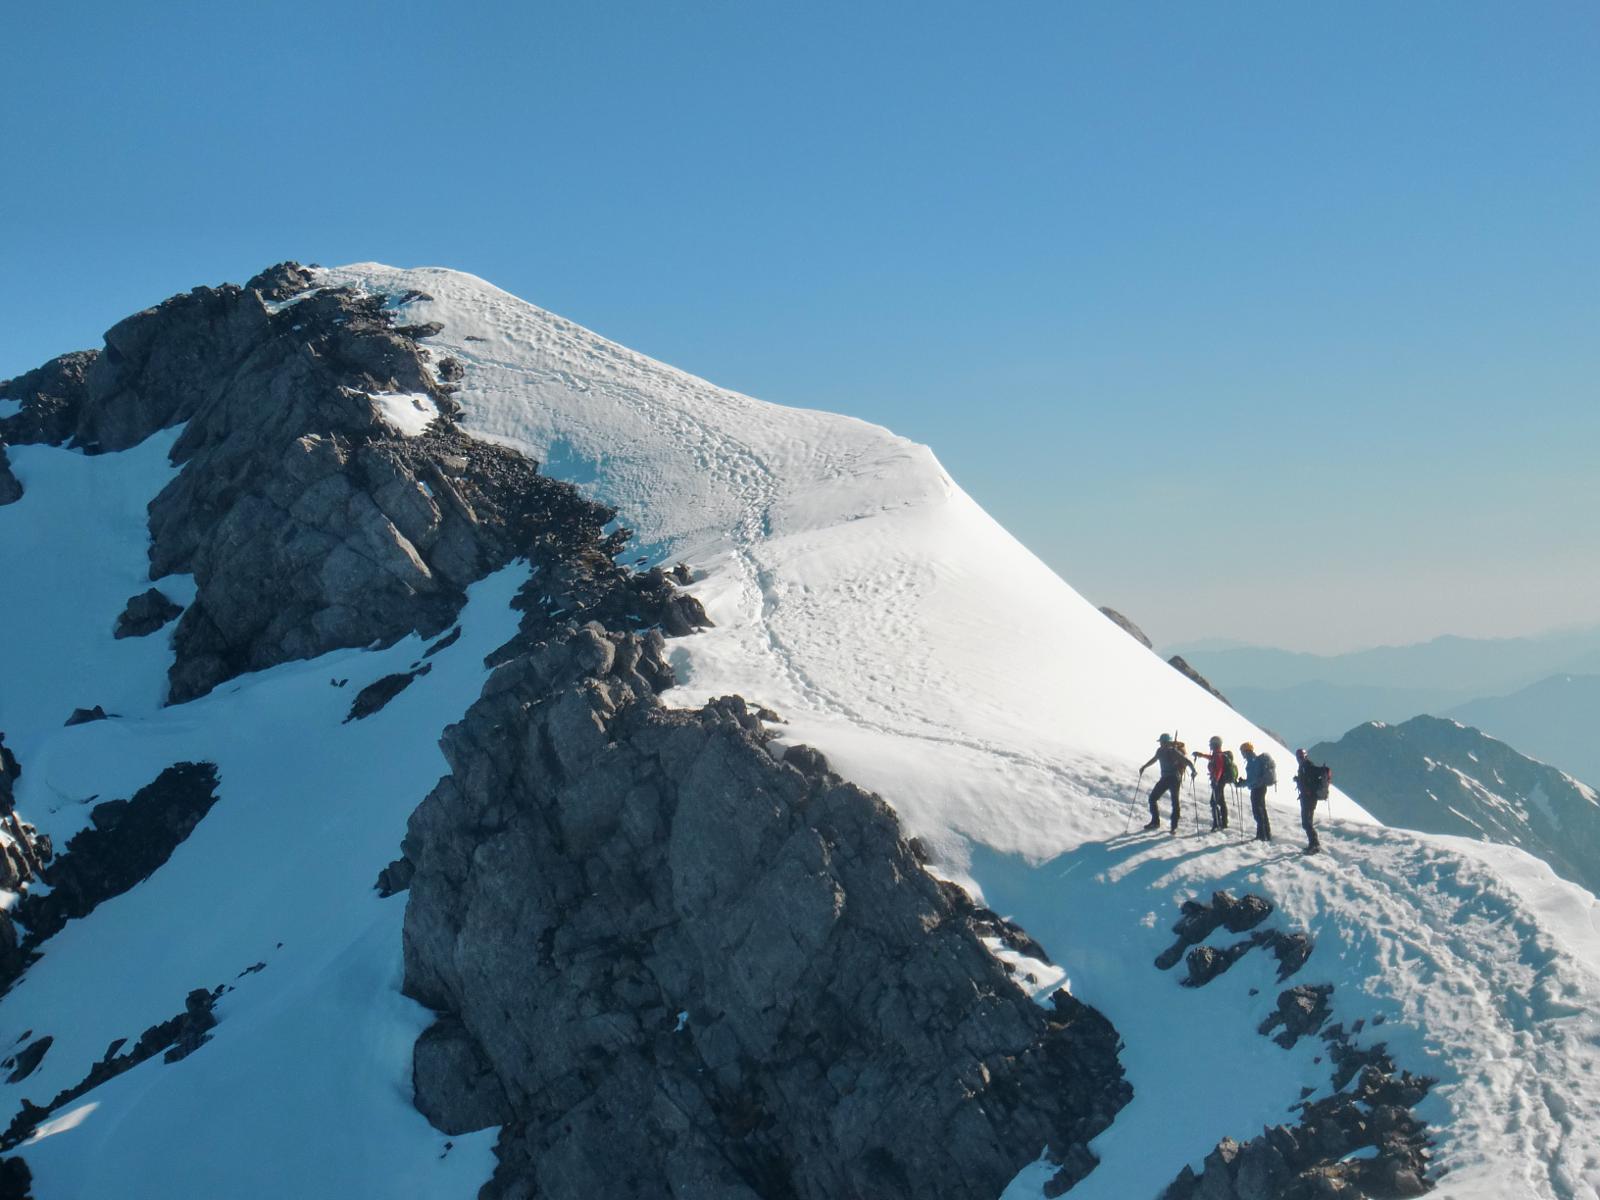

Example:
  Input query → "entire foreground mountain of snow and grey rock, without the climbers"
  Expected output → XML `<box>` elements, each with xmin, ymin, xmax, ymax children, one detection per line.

<box><xmin>0</xmin><ymin>264</ymin><xmax>1600</xmax><ymax>1200</ymax></box>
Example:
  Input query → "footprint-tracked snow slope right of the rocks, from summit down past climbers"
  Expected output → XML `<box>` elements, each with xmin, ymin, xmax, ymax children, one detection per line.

<box><xmin>323</xmin><ymin>264</ymin><xmax>1600</xmax><ymax>1198</ymax></box>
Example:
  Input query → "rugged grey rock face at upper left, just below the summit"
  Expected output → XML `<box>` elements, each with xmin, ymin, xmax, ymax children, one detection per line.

<box><xmin>0</xmin><ymin>264</ymin><xmax>704</xmax><ymax>702</ymax></box>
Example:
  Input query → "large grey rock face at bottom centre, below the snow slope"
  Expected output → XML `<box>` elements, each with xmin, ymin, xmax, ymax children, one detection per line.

<box><xmin>403</xmin><ymin>626</ymin><xmax>1130</xmax><ymax>1200</ymax></box>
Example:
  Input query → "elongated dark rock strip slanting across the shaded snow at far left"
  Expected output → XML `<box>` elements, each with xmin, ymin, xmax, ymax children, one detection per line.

<box><xmin>5</xmin><ymin>763</ymin><xmax>218</xmax><ymax>982</ymax></box>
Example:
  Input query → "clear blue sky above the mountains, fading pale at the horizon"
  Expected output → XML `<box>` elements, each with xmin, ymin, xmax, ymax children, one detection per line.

<box><xmin>0</xmin><ymin>0</ymin><xmax>1600</xmax><ymax>650</ymax></box>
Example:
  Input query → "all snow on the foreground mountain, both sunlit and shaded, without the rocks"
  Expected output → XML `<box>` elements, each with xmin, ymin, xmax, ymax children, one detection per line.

<box><xmin>0</xmin><ymin>266</ymin><xmax>1600</xmax><ymax>1197</ymax></box>
